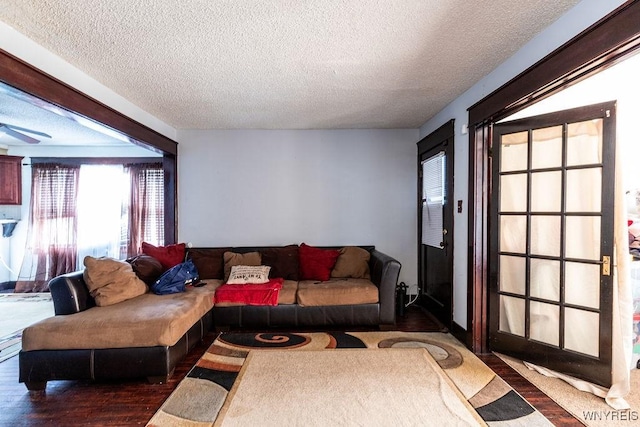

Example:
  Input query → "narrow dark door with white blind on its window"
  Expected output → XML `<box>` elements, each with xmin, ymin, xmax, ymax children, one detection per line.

<box><xmin>418</xmin><ymin>120</ymin><xmax>454</xmax><ymax>328</ymax></box>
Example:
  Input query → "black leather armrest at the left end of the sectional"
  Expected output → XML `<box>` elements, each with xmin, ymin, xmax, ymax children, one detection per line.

<box><xmin>49</xmin><ymin>271</ymin><xmax>96</xmax><ymax>316</ymax></box>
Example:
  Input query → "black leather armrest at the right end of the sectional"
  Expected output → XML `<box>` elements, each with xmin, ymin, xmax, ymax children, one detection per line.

<box><xmin>369</xmin><ymin>249</ymin><xmax>401</xmax><ymax>325</ymax></box>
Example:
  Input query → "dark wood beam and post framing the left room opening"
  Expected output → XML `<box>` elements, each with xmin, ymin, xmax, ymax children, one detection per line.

<box><xmin>0</xmin><ymin>49</ymin><xmax>178</xmax><ymax>244</ymax></box>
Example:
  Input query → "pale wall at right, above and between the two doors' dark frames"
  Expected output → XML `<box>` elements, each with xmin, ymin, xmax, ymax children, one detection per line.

<box><xmin>420</xmin><ymin>0</ymin><xmax>624</xmax><ymax>329</ymax></box>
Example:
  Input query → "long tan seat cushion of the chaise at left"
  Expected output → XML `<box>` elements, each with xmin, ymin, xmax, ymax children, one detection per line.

<box><xmin>22</xmin><ymin>280</ymin><xmax>221</xmax><ymax>351</ymax></box>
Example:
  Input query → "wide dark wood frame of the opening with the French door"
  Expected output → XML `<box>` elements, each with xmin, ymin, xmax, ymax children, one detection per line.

<box><xmin>464</xmin><ymin>1</ymin><xmax>640</xmax><ymax>353</ymax></box>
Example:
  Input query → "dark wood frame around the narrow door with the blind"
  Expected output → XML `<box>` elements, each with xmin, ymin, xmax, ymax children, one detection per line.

<box><xmin>417</xmin><ymin>119</ymin><xmax>455</xmax><ymax>329</ymax></box>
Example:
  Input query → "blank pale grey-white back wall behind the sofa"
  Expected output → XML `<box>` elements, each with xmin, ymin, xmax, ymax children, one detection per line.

<box><xmin>178</xmin><ymin>129</ymin><xmax>418</xmax><ymax>284</ymax></box>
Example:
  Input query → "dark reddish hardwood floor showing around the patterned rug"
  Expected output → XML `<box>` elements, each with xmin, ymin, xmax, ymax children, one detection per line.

<box><xmin>0</xmin><ymin>306</ymin><xmax>582</xmax><ymax>426</ymax></box>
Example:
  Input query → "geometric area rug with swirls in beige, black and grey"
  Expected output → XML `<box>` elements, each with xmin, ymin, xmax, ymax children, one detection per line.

<box><xmin>147</xmin><ymin>331</ymin><xmax>552</xmax><ymax>427</ymax></box>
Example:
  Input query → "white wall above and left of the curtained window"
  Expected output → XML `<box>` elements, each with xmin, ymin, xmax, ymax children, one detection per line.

<box><xmin>0</xmin><ymin>145</ymin><xmax>158</xmax><ymax>283</ymax></box>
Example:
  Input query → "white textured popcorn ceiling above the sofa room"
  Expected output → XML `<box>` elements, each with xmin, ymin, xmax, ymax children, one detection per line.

<box><xmin>0</xmin><ymin>0</ymin><xmax>578</xmax><ymax>129</ymax></box>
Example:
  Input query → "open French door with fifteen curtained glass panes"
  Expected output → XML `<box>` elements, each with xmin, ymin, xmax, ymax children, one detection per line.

<box><xmin>489</xmin><ymin>102</ymin><xmax>616</xmax><ymax>387</ymax></box>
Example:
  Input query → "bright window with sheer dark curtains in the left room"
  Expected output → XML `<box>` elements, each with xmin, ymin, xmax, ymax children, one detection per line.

<box><xmin>16</xmin><ymin>159</ymin><xmax>164</xmax><ymax>292</ymax></box>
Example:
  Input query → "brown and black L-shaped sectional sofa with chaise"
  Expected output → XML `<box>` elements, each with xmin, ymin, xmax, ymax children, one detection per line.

<box><xmin>19</xmin><ymin>244</ymin><xmax>400</xmax><ymax>391</ymax></box>
